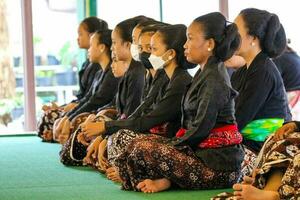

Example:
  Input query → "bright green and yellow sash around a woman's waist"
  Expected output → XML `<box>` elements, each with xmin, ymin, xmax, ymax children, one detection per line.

<box><xmin>241</xmin><ymin>118</ymin><xmax>284</xmax><ymax>142</ymax></box>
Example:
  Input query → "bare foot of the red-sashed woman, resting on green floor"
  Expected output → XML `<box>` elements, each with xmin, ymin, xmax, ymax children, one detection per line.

<box><xmin>136</xmin><ymin>178</ymin><xmax>171</xmax><ymax>193</ymax></box>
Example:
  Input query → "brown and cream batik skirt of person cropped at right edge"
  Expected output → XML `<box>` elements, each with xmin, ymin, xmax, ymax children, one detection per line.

<box><xmin>255</xmin><ymin>132</ymin><xmax>300</xmax><ymax>200</ymax></box>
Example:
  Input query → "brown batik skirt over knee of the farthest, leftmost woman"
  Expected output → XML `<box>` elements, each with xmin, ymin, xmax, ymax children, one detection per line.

<box><xmin>37</xmin><ymin>109</ymin><xmax>63</xmax><ymax>142</ymax></box>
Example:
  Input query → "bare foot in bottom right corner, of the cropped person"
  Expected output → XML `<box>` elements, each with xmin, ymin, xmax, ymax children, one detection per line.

<box><xmin>233</xmin><ymin>184</ymin><xmax>280</xmax><ymax>200</ymax></box>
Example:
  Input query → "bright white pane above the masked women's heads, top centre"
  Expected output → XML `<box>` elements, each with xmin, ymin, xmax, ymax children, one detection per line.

<box><xmin>163</xmin><ymin>0</ymin><xmax>219</xmax><ymax>25</ymax></box>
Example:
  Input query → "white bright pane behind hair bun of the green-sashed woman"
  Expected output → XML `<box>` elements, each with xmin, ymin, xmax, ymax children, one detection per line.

<box><xmin>229</xmin><ymin>0</ymin><xmax>300</xmax><ymax>53</ymax></box>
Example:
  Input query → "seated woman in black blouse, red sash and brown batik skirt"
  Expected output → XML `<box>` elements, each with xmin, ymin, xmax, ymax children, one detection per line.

<box><xmin>115</xmin><ymin>13</ymin><xmax>243</xmax><ymax>193</ymax></box>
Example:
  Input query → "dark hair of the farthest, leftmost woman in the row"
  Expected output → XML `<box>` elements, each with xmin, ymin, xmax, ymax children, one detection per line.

<box><xmin>80</xmin><ymin>17</ymin><xmax>108</xmax><ymax>33</ymax></box>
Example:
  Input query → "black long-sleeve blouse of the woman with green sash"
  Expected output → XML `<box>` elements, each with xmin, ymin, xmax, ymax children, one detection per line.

<box><xmin>231</xmin><ymin>52</ymin><xmax>290</xmax><ymax>151</ymax></box>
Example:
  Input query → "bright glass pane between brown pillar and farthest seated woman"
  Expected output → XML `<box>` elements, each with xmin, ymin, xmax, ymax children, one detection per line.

<box><xmin>32</xmin><ymin>0</ymin><xmax>81</xmax><ymax>119</ymax></box>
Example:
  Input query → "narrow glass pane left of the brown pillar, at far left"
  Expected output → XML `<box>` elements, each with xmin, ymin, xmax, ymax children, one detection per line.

<box><xmin>0</xmin><ymin>0</ymin><xmax>24</xmax><ymax>134</ymax></box>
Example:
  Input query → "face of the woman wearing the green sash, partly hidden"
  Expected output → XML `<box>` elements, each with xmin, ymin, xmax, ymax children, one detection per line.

<box><xmin>234</xmin><ymin>15</ymin><xmax>254</xmax><ymax>57</ymax></box>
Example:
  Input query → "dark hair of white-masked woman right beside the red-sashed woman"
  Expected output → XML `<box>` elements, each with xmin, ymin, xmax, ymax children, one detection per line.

<box><xmin>158</xmin><ymin>24</ymin><xmax>195</xmax><ymax>69</ymax></box>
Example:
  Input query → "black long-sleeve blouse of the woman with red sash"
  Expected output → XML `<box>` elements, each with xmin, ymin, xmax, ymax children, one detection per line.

<box><xmin>171</xmin><ymin>57</ymin><xmax>244</xmax><ymax>171</ymax></box>
